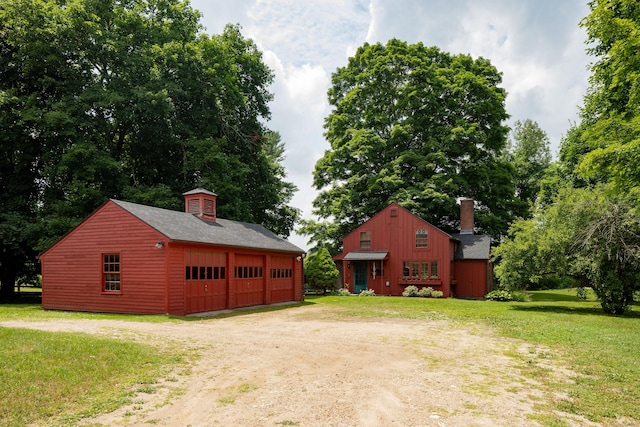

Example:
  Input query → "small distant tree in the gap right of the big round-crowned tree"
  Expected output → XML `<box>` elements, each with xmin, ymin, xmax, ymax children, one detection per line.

<box><xmin>506</xmin><ymin>119</ymin><xmax>551</xmax><ymax>210</ymax></box>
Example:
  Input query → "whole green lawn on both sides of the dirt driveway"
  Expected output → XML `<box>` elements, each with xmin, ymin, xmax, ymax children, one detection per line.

<box><xmin>0</xmin><ymin>290</ymin><xmax>640</xmax><ymax>426</ymax></box>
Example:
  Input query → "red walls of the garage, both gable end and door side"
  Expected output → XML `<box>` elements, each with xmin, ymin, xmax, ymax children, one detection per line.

<box><xmin>40</xmin><ymin>202</ymin><xmax>304</xmax><ymax>316</ymax></box>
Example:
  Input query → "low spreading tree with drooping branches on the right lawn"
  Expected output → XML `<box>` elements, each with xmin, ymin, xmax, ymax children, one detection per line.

<box><xmin>494</xmin><ymin>186</ymin><xmax>640</xmax><ymax>314</ymax></box>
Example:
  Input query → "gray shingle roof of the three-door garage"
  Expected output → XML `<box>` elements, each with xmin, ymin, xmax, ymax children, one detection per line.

<box><xmin>111</xmin><ymin>199</ymin><xmax>304</xmax><ymax>253</ymax></box>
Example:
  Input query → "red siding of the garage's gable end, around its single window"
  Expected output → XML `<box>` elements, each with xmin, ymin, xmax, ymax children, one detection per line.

<box><xmin>41</xmin><ymin>202</ymin><xmax>166</xmax><ymax>314</ymax></box>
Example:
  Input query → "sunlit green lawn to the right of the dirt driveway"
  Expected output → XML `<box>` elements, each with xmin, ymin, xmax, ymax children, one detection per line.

<box><xmin>307</xmin><ymin>289</ymin><xmax>640</xmax><ymax>426</ymax></box>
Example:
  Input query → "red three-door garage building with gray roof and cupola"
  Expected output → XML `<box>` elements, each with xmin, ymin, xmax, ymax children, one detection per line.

<box><xmin>40</xmin><ymin>189</ymin><xmax>304</xmax><ymax>316</ymax></box>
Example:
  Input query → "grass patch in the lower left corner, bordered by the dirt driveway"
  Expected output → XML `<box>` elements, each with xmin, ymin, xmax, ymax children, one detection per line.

<box><xmin>0</xmin><ymin>327</ymin><xmax>184</xmax><ymax>426</ymax></box>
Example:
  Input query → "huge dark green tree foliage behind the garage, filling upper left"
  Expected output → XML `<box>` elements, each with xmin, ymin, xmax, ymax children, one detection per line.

<box><xmin>0</xmin><ymin>0</ymin><xmax>298</xmax><ymax>300</ymax></box>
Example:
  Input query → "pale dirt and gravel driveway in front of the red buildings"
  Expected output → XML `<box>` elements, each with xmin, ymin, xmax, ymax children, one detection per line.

<box><xmin>0</xmin><ymin>305</ymin><xmax>588</xmax><ymax>427</ymax></box>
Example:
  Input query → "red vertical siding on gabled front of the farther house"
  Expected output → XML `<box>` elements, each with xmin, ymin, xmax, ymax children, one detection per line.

<box><xmin>337</xmin><ymin>203</ymin><xmax>452</xmax><ymax>296</ymax></box>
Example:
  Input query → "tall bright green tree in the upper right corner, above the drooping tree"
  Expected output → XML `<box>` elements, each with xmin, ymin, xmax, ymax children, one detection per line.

<box><xmin>576</xmin><ymin>0</ymin><xmax>640</xmax><ymax>197</ymax></box>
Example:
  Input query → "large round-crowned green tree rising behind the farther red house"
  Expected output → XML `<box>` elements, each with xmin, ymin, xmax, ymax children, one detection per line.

<box><xmin>302</xmin><ymin>39</ymin><xmax>517</xmax><ymax>252</ymax></box>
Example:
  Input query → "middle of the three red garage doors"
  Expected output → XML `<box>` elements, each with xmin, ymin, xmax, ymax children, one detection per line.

<box><xmin>233</xmin><ymin>254</ymin><xmax>265</xmax><ymax>307</ymax></box>
